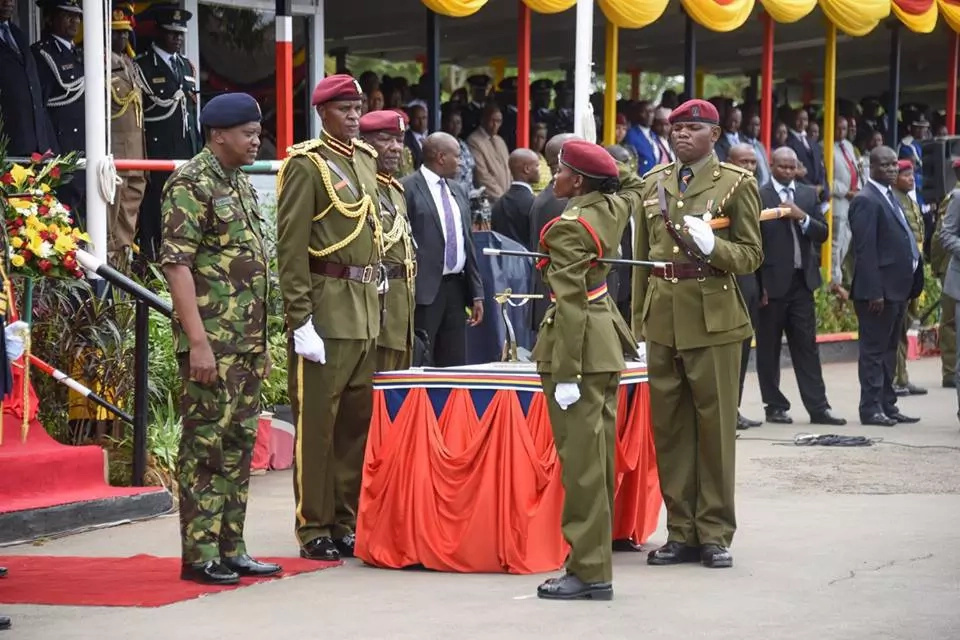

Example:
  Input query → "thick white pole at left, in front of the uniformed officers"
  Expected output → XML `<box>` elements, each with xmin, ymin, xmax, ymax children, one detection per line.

<box><xmin>83</xmin><ymin>0</ymin><xmax>110</xmax><ymax>260</ymax></box>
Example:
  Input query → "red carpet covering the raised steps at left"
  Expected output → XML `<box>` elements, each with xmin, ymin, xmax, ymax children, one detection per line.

<box><xmin>0</xmin><ymin>416</ymin><xmax>159</xmax><ymax>513</ymax></box>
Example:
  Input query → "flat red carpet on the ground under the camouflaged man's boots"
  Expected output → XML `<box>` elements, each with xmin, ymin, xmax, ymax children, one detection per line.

<box><xmin>0</xmin><ymin>555</ymin><xmax>341</xmax><ymax>607</ymax></box>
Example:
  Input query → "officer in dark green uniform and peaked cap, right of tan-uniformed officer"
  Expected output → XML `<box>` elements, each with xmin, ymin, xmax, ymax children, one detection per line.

<box><xmin>136</xmin><ymin>6</ymin><xmax>202</xmax><ymax>260</ymax></box>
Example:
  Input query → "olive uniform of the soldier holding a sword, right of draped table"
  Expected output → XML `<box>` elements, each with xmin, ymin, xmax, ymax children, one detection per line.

<box><xmin>633</xmin><ymin>153</ymin><xmax>763</xmax><ymax>547</ymax></box>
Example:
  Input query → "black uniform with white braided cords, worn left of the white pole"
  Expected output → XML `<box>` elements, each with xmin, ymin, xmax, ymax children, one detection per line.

<box><xmin>30</xmin><ymin>34</ymin><xmax>87</xmax><ymax>221</ymax></box>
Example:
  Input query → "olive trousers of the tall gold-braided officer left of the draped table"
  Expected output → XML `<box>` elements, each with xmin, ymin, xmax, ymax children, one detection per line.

<box><xmin>288</xmin><ymin>338</ymin><xmax>376</xmax><ymax>545</ymax></box>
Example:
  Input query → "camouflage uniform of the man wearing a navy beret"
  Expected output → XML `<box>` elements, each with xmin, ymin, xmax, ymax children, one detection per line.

<box><xmin>160</xmin><ymin>148</ymin><xmax>268</xmax><ymax>564</ymax></box>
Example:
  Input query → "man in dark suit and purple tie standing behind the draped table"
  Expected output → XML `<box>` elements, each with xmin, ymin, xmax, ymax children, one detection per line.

<box><xmin>403</xmin><ymin>132</ymin><xmax>483</xmax><ymax>367</ymax></box>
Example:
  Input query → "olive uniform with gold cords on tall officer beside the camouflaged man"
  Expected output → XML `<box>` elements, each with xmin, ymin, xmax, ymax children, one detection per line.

<box><xmin>277</xmin><ymin>134</ymin><xmax>380</xmax><ymax>545</ymax></box>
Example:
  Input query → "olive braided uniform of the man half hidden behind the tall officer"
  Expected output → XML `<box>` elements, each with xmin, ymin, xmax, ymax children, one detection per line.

<box><xmin>377</xmin><ymin>173</ymin><xmax>417</xmax><ymax>371</ymax></box>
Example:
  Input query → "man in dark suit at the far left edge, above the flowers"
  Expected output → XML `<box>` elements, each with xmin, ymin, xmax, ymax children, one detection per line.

<box><xmin>0</xmin><ymin>0</ymin><xmax>59</xmax><ymax>156</ymax></box>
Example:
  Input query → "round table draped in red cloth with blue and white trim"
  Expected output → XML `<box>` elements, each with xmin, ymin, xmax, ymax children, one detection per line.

<box><xmin>356</xmin><ymin>363</ymin><xmax>662</xmax><ymax>574</ymax></box>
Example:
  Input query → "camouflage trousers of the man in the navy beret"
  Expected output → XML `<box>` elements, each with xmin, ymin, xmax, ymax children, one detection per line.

<box><xmin>177</xmin><ymin>353</ymin><xmax>267</xmax><ymax>564</ymax></box>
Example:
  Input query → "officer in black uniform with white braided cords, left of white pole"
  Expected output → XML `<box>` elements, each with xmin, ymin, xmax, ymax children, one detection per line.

<box><xmin>30</xmin><ymin>0</ymin><xmax>87</xmax><ymax>221</ymax></box>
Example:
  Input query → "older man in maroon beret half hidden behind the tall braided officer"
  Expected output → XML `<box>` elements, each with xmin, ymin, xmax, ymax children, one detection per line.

<box><xmin>360</xmin><ymin>111</ymin><xmax>417</xmax><ymax>371</ymax></box>
